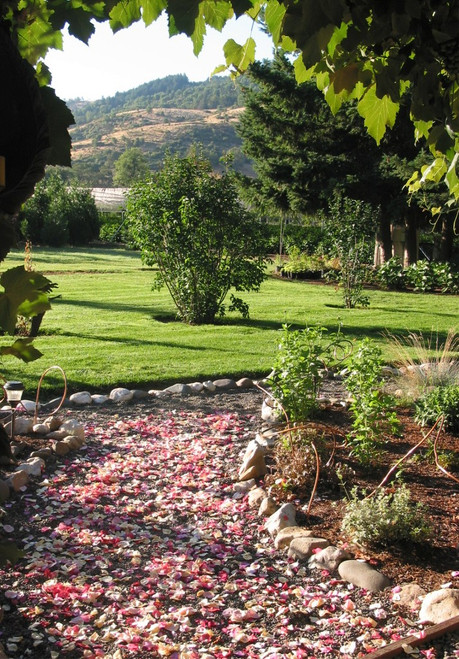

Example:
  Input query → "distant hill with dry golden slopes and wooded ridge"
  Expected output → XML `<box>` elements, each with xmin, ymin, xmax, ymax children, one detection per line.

<box><xmin>68</xmin><ymin>75</ymin><xmax>253</xmax><ymax>187</ymax></box>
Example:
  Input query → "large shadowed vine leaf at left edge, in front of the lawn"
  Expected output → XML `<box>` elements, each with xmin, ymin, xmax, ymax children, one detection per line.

<box><xmin>0</xmin><ymin>265</ymin><xmax>52</xmax><ymax>334</ymax></box>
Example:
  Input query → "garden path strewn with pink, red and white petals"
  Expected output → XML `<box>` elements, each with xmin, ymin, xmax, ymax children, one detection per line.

<box><xmin>1</xmin><ymin>412</ymin><xmax>436</xmax><ymax>659</ymax></box>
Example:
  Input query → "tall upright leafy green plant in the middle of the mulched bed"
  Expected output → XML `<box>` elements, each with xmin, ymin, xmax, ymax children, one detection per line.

<box><xmin>345</xmin><ymin>339</ymin><xmax>399</xmax><ymax>464</ymax></box>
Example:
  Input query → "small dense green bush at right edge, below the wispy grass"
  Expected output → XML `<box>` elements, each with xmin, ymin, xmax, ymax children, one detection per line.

<box><xmin>415</xmin><ymin>385</ymin><xmax>459</xmax><ymax>432</ymax></box>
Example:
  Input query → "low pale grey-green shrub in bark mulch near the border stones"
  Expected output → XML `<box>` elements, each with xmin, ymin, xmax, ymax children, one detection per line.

<box><xmin>341</xmin><ymin>484</ymin><xmax>432</xmax><ymax>546</ymax></box>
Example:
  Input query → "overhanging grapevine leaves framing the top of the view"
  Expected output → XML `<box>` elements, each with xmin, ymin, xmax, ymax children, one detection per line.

<box><xmin>0</xmin><ymin>0</ymin><xmax>459</xmax><ymax>237</ymax></box>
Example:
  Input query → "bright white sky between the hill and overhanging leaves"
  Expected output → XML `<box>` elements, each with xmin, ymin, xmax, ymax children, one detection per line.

<box><xmin>45</xmin><ymin>16</ymin><xmax>272</xmax><ymax>101</ymax></box>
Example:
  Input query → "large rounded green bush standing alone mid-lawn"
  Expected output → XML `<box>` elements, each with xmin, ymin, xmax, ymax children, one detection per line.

<box><xmin>127</xmin><ymin>153</ymin><xmax>265</xmax><ymax>323</ymax></box>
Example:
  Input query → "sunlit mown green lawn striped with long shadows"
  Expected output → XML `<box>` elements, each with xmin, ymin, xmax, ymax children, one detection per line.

<box><xmin>2</xmin><ymin>248</ymin><xmax>457</xmax><ymax>398</ymax></box>
